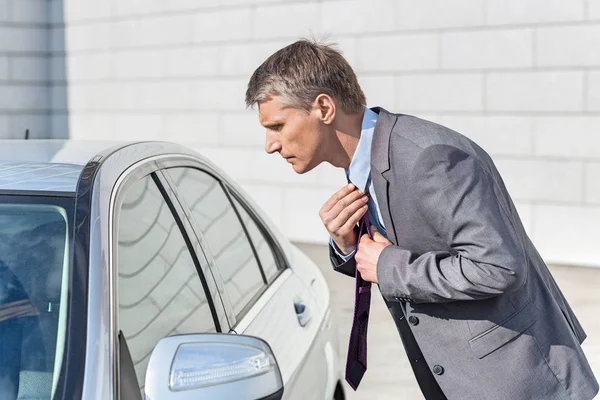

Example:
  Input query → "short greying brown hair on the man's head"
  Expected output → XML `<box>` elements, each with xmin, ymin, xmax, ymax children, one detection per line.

<box><xmin>246</xmin><ymin>39</ymin><xmax>367</xmax><ymax>114</ymax></box>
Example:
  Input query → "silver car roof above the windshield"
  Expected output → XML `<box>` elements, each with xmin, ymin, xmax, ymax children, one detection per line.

<box><xmin>0</xmin><ymin>140</ymin><xmax>127</xmax><ymax>192</ymax></box>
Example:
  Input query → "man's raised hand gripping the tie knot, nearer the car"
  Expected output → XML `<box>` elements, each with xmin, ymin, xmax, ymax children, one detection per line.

<box><xmin>319</xmin><ymin>184</ymin><xmax>368</xmax><ymax>254</ymax></box>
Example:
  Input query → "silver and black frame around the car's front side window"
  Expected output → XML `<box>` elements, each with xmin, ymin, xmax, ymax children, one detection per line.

<box><xmin>109</xmin><ymin>160</ymin><xmax>224</xmax><ymax>398</ymax></box>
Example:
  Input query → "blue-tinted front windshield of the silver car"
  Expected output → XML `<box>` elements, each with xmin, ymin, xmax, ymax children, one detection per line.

<box><xmin>0</xmin><ymin>195</ymin><xmax>71</xmax><ymax>399</ymax></box>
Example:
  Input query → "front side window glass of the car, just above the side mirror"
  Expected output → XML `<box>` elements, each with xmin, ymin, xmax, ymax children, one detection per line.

<box><xmin>118</xmin><ymin>176</ymin><xmax>216</xmax><ymax>388</ymax></box>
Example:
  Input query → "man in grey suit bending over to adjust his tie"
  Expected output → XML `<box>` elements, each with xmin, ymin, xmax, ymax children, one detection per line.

<box><xmin>246</xmin><ymin>40</ymin><xmax>598</xmax><ymax>400</ymax></box>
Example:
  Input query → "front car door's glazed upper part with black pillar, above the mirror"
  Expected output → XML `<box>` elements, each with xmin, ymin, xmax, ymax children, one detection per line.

<box><xmin>113</xmin><ymin>173</ymin><xmax>227</xmax><ymax>398</ymax></box>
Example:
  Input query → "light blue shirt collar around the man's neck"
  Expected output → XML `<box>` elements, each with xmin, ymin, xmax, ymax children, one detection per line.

<box><xmin>346</xmin><ymin>107</ymin><xmax>379</xmax><ymax>192</ymax></box>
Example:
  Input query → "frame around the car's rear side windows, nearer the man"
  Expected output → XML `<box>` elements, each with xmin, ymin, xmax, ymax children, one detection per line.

<box><xmin>159</xmin><ymin>156</ymin><xmax>289</xmax><ymax>331</ymax></box>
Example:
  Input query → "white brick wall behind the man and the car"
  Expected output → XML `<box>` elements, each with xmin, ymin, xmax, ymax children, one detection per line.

<box><xmin>0</xmin><ymin>0</ymin><xmax>600</xmax><ymax>265</ymax></box>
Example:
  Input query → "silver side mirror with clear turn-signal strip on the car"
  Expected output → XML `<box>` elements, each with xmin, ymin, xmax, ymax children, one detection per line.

<box><xmin>144</xmin><ymin>333</ymin><xmax>283</xmax><ymax>400</ymax></box>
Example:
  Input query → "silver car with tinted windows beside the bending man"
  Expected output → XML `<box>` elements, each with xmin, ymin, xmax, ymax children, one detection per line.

<box><xmin>0</xmin><ymin>141</ymin><xmax>344</xmax><ymax>400</ymax></box>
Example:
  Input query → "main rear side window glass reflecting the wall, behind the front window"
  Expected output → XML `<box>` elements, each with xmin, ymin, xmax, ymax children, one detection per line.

<box><xmin>167</xmin><ymin>168</ymin><xmax>266</xmax><ymax>316</ymax></box>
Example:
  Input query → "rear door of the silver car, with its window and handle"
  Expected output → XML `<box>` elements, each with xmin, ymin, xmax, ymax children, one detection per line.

<box><xmin>165</xmin><ymin>164</ymin><xmax>327</xmax><ymax>399</ymax></box>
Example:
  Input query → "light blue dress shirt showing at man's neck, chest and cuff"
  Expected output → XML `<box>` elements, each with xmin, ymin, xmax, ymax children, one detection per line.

<box><xmin>329</xmin><ymin>108</ymin><xmax>387</xmax><ymax>261</ymax></box>
